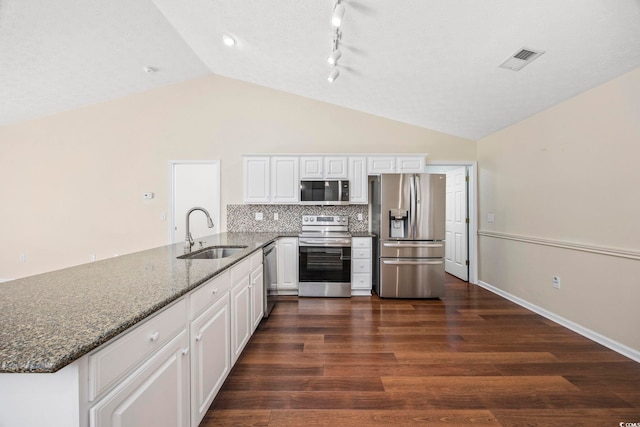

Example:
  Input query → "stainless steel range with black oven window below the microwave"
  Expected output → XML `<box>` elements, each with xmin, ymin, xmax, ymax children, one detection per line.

<box><xmin>298</xmin><ymin>215</ymin><xmax>351</xmax><ymax>297</ymax></box>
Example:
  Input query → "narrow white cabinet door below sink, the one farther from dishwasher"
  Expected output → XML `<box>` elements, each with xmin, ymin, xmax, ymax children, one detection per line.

<box><xmin>231</xmin><ymin>275</ymin><xmax>251</xmax><ymax>365</ymax></box>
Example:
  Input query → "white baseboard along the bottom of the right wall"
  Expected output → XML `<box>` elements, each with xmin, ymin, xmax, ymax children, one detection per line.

<box><xmin>478</xmin><ymin>280</ymin><xmax>640</xmax><ymax>363</ymax></box>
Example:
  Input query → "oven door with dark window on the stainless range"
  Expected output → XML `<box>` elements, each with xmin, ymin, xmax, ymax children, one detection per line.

<box><xmin>298</xmin><ymin>246</ymin><xmax>351</xmax><ymax>297</ymax></box>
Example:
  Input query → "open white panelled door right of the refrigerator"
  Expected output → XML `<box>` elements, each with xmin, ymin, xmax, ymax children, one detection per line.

<box><xmin>444</xmin><ymin>166</ymin><xmax>469</xmax><ymax>281</ymax></box>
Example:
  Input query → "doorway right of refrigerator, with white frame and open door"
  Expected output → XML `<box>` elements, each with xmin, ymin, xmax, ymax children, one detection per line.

<box><xmin>425</xmin><ymin>162</ymin><xmax>478</xmax><ymax>284</ymax></box>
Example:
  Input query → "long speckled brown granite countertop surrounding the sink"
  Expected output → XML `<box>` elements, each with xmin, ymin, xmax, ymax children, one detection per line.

<box><xmin>0</xmin><ymin>233</ymin><xmax>284</xmax><ymax>373</ymax></box>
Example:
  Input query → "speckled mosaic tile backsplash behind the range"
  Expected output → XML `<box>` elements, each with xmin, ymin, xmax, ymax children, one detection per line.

<box><xmin>227</xmin><ymin>204</ymin><xmax>369</xmax><ymax>233</ymax></box>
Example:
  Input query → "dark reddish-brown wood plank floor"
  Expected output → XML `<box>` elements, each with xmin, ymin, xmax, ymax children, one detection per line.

<box><xmin>201</xmin><ymin>276</ymin><xmax>640</xmax><ymax>427</ymax></box>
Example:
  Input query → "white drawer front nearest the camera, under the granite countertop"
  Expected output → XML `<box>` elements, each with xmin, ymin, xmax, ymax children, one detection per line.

<box><xmin>89</xmin><ymin>298</ymin><xmax>187</xmax><ymax>401</ymax></box>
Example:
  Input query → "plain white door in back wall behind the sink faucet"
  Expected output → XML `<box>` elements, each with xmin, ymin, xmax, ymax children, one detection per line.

<box><xmin>170</xmin><ymin>160</ymin><xmax>220</xmax><ymax>243</ymax></box>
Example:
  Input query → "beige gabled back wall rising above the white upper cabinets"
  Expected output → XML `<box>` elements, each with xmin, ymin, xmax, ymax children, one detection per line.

<box><xmin>0</xmin><ymin>76</ymin><xmax>476</xmax><ymax>279</ymax></box>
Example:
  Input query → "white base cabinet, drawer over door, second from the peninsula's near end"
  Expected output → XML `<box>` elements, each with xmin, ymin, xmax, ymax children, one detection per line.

<box><xmin>190</xmin><ymin>271</ymin><xmax>231</xmax><ymax>427</ymax></box>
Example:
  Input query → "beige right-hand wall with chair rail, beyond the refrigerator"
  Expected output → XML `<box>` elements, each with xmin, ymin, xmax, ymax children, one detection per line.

<box><xmin>478</xmin><ymin>69</ymin><xmax>640</xmax><ymax>351</ymax></box>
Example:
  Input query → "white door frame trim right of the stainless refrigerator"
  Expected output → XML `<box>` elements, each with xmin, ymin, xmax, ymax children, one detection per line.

<box><xmin>425</xmin><ymin>159</ymin><xmax>478</xmax><ymax>285</ymax></box>
